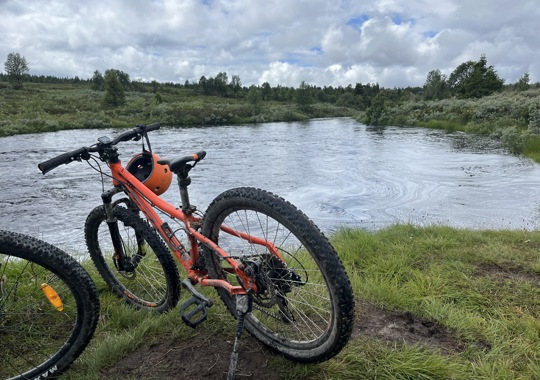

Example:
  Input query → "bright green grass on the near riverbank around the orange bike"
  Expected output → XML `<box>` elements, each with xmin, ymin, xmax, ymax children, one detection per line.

<box><xmin>56</xmin><ymin>225</ymin><xmax>540</xmax><ymax>380</ymax></box>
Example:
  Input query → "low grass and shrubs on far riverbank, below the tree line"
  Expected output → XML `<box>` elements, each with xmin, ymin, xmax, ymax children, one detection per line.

<box><xmin>0</xmin><ymin>82</ymin><xmax>540</xmax><ymax>162</ymax></box>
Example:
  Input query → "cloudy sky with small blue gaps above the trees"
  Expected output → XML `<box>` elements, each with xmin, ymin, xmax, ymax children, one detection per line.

<box><xmin>0</xmin><ymin>0</ymin><xmax>540</xmax><ymax>88</ymax></box>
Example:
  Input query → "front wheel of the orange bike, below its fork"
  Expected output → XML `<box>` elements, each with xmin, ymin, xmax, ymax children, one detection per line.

<box><xmin>84</xmin><ymin>206</ymin><xmax>180</xmax><ymax>312</ymax></box>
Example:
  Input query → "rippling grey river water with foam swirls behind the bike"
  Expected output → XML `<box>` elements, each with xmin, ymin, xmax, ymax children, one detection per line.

<box><xmin>0</xmin><ymin>118</ymin><xmax>540</xmax><ymax>250</ymax></box>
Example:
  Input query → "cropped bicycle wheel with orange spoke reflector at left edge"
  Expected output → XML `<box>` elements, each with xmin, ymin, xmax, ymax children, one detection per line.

<box><xmin>0</xmin><ymin>231</ymin><xmax>99</xmax><ymax>379</ymax></box>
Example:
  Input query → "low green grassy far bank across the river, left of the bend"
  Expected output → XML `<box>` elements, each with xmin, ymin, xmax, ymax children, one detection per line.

<box><xmin>0</xmin><ymin>83</ymin><xmax>355</xmax><ymax>137</ymax></box>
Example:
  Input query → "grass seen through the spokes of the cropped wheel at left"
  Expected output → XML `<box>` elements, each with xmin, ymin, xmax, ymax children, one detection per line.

<box><xmin>0</xmin><ymin>255</ymin><xmax>82</xmax><ymax>378</ymax></box>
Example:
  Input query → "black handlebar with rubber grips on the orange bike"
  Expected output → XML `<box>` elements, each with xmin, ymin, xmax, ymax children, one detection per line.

<box><xmin>38</xmin><ymin>123</ymin><xmax>160</xmax><ymax>174</ymax></box>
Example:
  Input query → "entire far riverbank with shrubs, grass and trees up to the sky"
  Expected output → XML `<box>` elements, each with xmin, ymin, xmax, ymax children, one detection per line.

<box><xmin>0</xmin><ymin>53</ymin><xmax>540</xmax><ymax>162</ymax></box>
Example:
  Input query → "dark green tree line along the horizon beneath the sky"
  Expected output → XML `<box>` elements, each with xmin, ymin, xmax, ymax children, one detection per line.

<box><xmin>0</xmin><ymin>53</ymin><xmax>540</xmax><ymax>113</ymax></box>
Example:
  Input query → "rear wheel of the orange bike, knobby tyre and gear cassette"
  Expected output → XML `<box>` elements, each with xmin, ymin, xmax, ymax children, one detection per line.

<box><xmin>202</xmin><ymin>188</ymin><xmax>354</xmax><ymax>362</ymax></box>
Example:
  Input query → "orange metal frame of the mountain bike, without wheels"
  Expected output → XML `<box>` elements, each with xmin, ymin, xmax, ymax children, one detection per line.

<box><xmin>104</xmin><ymin>161</ymin><xmax>285</xmax><ymax>295</ymax></box>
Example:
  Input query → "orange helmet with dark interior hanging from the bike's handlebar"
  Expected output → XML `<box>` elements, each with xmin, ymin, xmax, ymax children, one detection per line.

<box><xmin>126</xmin><ymin>151</ymin><xmax>172</xmax><ymax>195</ymax></box>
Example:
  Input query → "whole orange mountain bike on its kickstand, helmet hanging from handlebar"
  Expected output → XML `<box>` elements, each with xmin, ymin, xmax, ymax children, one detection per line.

<box><xmin>39</xmin><ymin>124</ymin><xmax>354</xmax><ymax>378</ymax></box>
